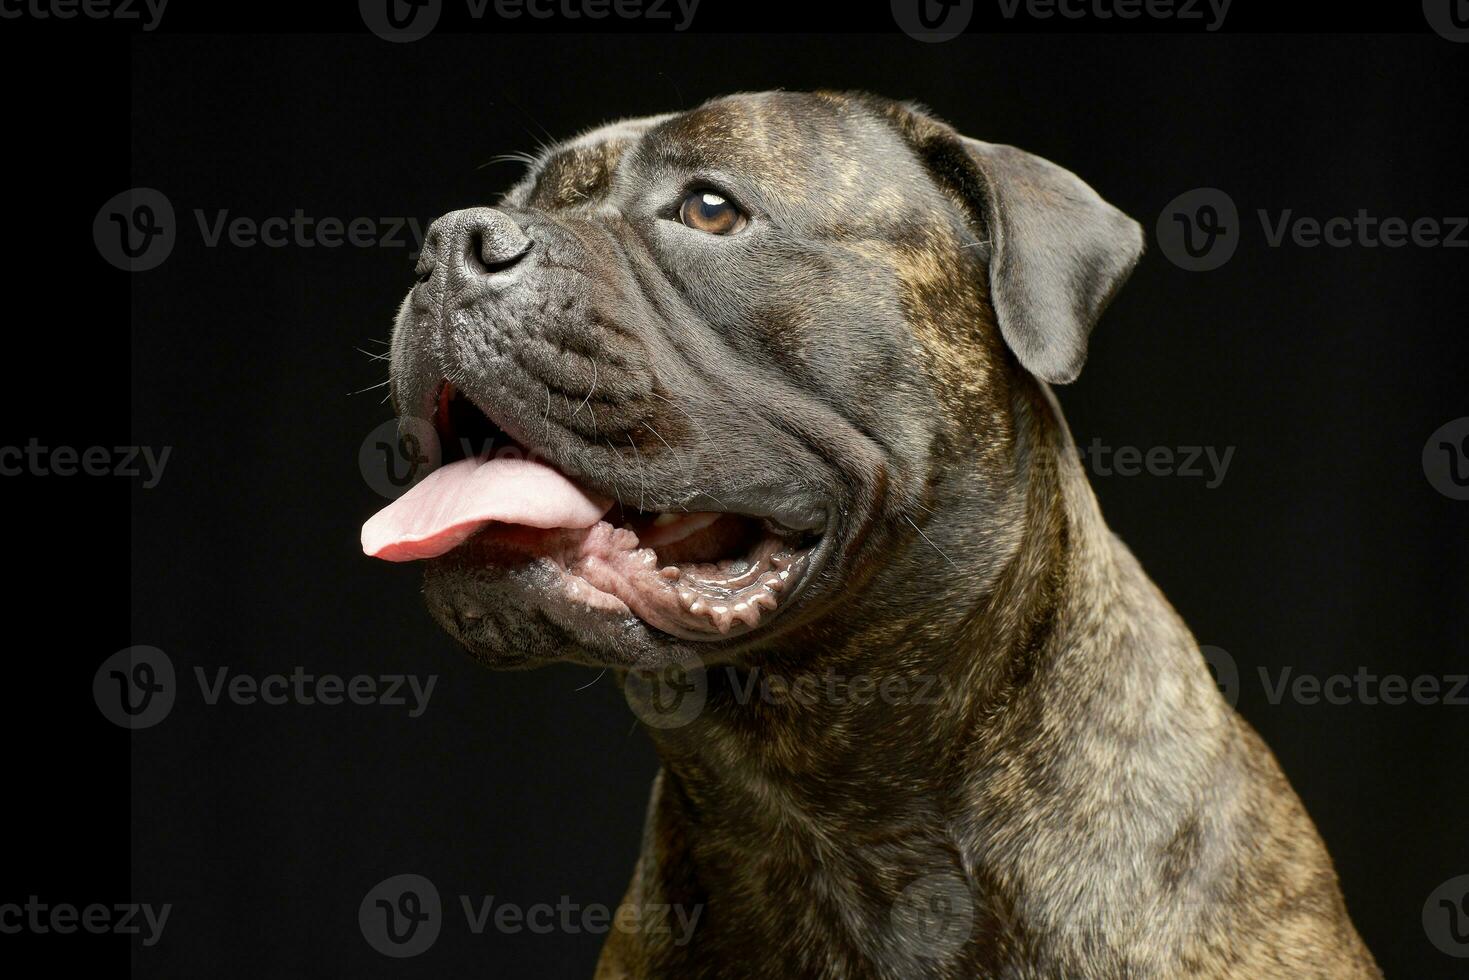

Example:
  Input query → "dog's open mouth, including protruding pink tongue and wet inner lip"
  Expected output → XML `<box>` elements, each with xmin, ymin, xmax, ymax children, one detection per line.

<box><xmin>363</xmin><ymin>383</ymin><xmax>821</xmax><ymax>639</ymax></box>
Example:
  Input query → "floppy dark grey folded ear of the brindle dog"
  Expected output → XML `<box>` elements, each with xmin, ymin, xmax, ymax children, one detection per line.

<box><xmin>898</xmin><ymin>106</ymin><xmax>1143</xmax><ymax>383</ymax></box>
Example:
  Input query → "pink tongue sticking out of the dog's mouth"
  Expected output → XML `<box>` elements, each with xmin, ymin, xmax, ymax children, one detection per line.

<box><xmin>363</xmin><ymin>458</ymin><xmax>613</xmax><ymax>561</ymax></box>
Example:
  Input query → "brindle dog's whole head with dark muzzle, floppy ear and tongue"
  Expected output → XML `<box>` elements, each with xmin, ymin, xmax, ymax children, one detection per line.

<box><xmin>363</xmin><ymin>93</ymin><xmax>1141</xmax><ymax>667</ymax></box>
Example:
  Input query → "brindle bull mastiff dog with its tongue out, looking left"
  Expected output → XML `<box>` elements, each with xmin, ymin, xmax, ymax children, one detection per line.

<box><xmin>363</xmin><ymin>93</ymin><xmax>1381</xmax><ymax>980</ymax></box>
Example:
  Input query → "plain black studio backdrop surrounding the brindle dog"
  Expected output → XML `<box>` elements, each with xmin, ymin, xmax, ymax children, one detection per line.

<box><xmin>4</xmin><ymin>0</ymin><xmax>1469</xmax><ymax>977</ymax></box>
